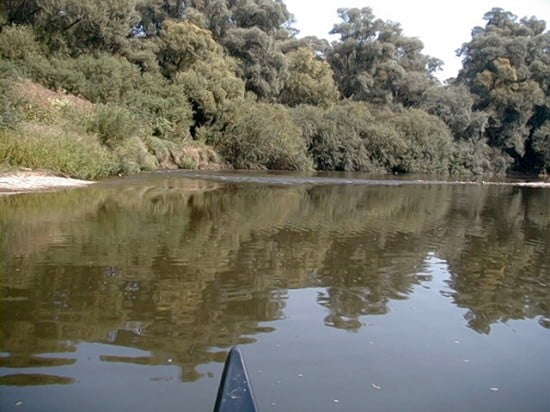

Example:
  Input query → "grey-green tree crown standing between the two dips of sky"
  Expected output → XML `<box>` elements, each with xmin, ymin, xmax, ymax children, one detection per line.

<box><xmin>328</xmin><ymin>7</ymin><xmax>438</xmax><ymax>103</ymax></box>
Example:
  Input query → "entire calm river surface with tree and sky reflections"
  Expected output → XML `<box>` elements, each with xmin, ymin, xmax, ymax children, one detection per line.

<box><xmin>0</xmin><ymin>173</ymin><xmax>550</xmax><ymax>412</ymax></box>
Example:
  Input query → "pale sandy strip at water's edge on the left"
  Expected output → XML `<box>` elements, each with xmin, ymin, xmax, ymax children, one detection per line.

<box><xmin>0</xmin><ymin>171</ymin><xmax>95</xmax><ymax>195</ymax></box>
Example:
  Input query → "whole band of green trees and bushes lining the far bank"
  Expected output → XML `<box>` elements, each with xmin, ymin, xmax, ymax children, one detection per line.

<box><xmin>0</xmin><ymin>0</ymin><xmax>550</xmax><ymax>177</ymax></box>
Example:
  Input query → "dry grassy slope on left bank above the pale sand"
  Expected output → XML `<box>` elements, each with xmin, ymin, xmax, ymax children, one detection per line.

<box><xmin>0</xmin><ymin>80</ymin><xmax>227</xmax><ymax>179</ymax></box>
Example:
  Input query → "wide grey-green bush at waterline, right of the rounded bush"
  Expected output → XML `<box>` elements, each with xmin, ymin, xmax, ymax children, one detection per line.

<box><xmin>293</xmin><ymin>102</ymin><xmax>460</xmax><ymax>173</ymax></box>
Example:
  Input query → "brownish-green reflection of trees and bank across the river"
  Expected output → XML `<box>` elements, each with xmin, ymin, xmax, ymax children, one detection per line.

<box><xmin>0</xmin><ymin>180</ymin><xmax>550</xmax><ymax>392</ymax></box>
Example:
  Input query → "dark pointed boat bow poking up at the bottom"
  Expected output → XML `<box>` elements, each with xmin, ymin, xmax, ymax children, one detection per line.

<box><xmin>214</xmin><ymin>346</ymin><xmax>258</xmax><ymax>412</ymax></box>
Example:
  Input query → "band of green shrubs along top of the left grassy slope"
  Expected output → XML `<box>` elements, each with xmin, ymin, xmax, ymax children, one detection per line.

<box><xmin>11</xmin><ymin>54</ymin><xmax>193</xmax><ymax>141</ymax></box>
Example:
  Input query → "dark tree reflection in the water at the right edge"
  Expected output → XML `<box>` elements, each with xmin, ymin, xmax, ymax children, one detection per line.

<box><xmin>442</xmin><ymin>189</ymin><xmax>550</xmax><ymax>334</ymax></box>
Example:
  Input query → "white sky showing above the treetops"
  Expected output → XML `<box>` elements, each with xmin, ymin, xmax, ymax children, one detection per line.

<box><xmin>283</xmin><ymin>0</ymin><xmax>550</xmax><ymax>80</ymax></box>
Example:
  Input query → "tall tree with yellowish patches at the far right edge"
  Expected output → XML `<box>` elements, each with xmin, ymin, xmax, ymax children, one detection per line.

<box><xmin>457</xmin><ymin>8</ymin><xmax>550</xmax><ymax>172</ymax></box>
